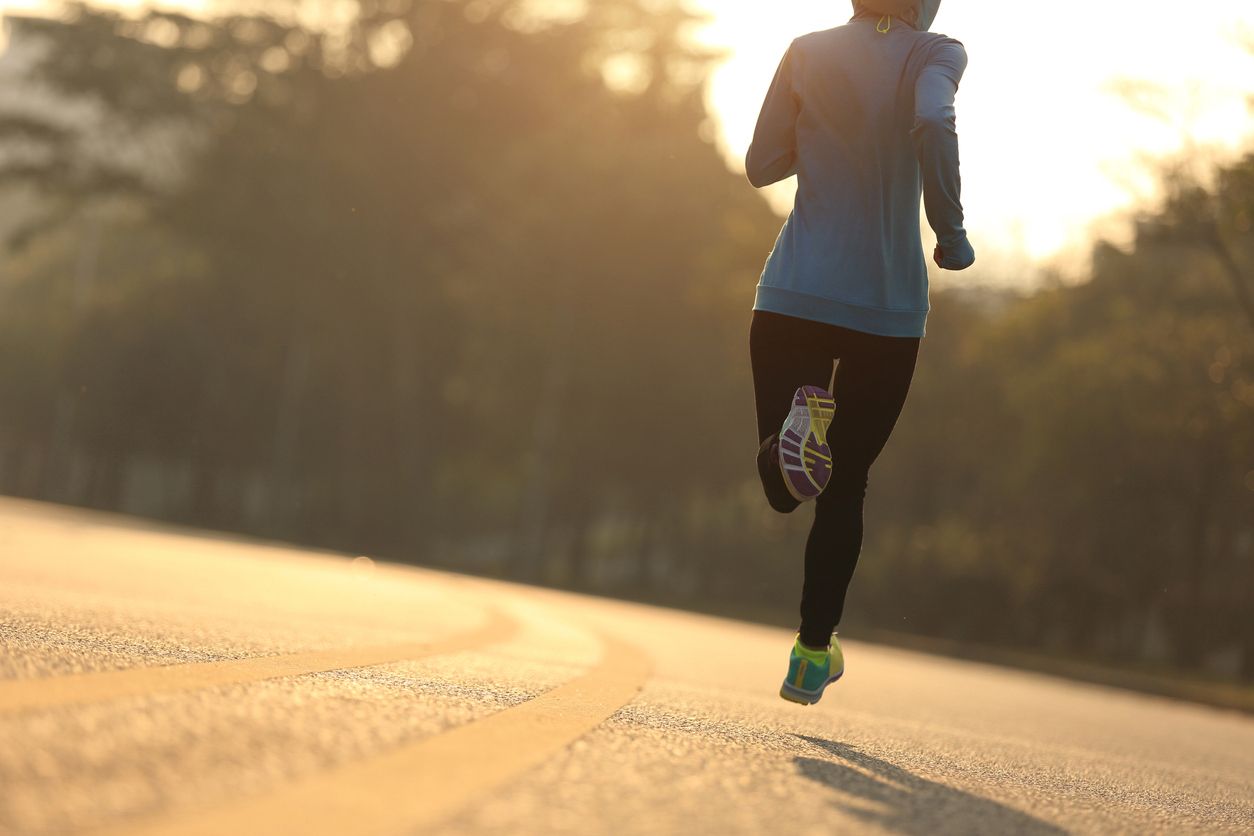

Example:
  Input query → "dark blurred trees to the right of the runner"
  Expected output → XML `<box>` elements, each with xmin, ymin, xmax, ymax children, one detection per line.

<box><xmin>856</xmin><ymin>155</ymin><xmax>1254</xmax><ymax>677</ymax></box>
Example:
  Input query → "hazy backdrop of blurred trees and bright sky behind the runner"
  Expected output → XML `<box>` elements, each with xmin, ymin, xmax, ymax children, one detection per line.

<box><xmin>0</xmin><ymin>0</ymin><xmax>1254</xmax><ymax>682</ymax></box>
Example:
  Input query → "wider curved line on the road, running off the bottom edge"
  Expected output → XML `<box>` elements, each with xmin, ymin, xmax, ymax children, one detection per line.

<box><xmin>93</xmin><ymin>637</ymin><xmax>651</xmax><ymax>836</ymax></box>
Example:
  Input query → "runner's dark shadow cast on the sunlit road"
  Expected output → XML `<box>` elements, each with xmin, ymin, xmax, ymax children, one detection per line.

<box><xmin>794</xmin><ymin>734</ymin><xmax>1067</xmax><ymax>836</ymax></box>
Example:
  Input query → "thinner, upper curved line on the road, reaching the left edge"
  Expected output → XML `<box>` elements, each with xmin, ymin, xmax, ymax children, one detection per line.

<box><xmin>0</xmin><ymin>609</ymin><xmax>518</xmax><ymax>716</ymax></box>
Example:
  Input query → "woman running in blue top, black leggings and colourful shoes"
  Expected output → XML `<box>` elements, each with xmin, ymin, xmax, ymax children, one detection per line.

<box><xmin>745</xmin><ymin>0</ymin><xmax>976</xmax><ymax>704</ymax></box>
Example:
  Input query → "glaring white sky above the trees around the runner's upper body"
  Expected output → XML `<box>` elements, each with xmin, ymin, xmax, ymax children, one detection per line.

<box><xmin>0</xmin><ymin>0</ymin><xmax>1254</xmax><ymax>268</ymax></box>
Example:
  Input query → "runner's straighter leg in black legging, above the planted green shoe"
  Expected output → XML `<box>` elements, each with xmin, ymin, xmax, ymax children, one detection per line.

<box><xmin>801</xmin><ymin>331</ymin><xmax>919</xmax><ymax>648</ymax></box>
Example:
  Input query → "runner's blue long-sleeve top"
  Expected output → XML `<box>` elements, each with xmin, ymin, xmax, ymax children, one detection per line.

<box><xmin>745</xmin><ymin>0</ymin><xmax>976</xmax><ymax>337</ymax></box>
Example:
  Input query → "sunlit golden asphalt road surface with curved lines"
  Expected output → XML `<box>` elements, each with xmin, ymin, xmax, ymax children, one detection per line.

<box><xmin>0</xmin><ymin>500</ymin><xmax>1254</xmax><ymax>835</ymax></box>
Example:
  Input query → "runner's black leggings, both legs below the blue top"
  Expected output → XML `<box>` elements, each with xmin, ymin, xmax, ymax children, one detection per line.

<box><xmin>749</xmin><ymin>311</ymin><xmax>919</xmax><ymax>647</ymax></box>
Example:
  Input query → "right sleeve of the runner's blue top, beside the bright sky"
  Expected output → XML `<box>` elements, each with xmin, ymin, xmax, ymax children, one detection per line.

<box><xmin>910</xmin><ymin>39</ymin><xmax>976</xmax><ymax>269</ymax></box>
